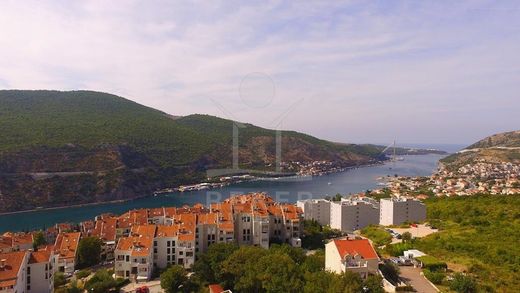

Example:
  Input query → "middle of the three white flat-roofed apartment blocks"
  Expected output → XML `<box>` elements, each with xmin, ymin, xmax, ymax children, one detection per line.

<box><xmin>330</xmin><ymin>197</ymin><xmax>379</xmax><ymax>232</ymax></box>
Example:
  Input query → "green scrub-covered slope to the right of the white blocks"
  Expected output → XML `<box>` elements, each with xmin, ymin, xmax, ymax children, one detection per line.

<box><xmin>392</xmin><ymin>196</ymin><xmax>520</xmax><ymax>292</ymax></box>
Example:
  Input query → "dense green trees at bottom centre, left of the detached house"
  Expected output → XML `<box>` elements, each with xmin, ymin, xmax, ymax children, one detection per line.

<box><xmin>161</xmin><ymin>243</ymin><xmax>384</xmax><ymax>293</ymax></box>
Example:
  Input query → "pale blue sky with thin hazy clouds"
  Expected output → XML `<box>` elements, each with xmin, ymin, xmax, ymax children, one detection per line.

<box><xmin>0</xmin><ymin>0</ymin><xmax>520</xmax><ymax>144</ymax></box>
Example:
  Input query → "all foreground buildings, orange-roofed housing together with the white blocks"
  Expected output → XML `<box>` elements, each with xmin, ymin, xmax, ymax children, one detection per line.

<box><xmin>0</xmin><ymin>193</ymin><xmax>426</xmax><ymax>293</ymax></box>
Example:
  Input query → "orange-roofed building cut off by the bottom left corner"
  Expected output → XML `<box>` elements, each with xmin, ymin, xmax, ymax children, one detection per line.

<box><xmin>0</xmin><ymin>251</ymin><xmax>28</xmax><ymax>293</ymax></box>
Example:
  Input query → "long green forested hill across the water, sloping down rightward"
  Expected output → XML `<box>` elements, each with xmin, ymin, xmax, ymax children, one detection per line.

<box><xmin>0</xmin><ymin>90</ymin><xmax>381</xmax><ymax>212</ymax></box>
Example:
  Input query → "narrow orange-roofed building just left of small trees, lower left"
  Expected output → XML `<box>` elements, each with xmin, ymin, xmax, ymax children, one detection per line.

<box><xmin>54</xmin><ymin>232</ymin><xmax>81</xmax><ymax>274</ymax></box>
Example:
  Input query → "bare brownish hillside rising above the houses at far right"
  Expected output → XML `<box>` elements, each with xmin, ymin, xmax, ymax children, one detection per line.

<box><xmin>441</xmin><ymin>131</ymin><xmax>520</xmax><ymax>168</ymax></box>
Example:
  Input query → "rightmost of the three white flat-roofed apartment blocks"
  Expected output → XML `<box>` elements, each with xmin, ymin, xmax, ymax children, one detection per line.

<box><xmin>379</xmin><ymin>197</ymin><xmax>426</xmax><ymax>226</ymax></box>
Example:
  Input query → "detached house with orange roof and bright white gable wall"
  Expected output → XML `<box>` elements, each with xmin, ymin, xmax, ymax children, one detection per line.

<box><xmin>325</xmin><ymin>239</ymin><xmax>379</xmax><ymax>278</ymax></box>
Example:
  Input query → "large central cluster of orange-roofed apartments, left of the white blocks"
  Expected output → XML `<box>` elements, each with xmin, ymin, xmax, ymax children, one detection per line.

<box><xmin>111</xmin><ymin>194</ymin><xmax>302</xmax><ymax>280</ymax></box>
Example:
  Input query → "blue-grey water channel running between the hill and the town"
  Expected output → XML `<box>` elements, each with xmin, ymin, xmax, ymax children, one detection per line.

<box><xmin>0</xmin><ymin>155</ymin><xmax>443</xmax><ymax>233</ymax></box>
